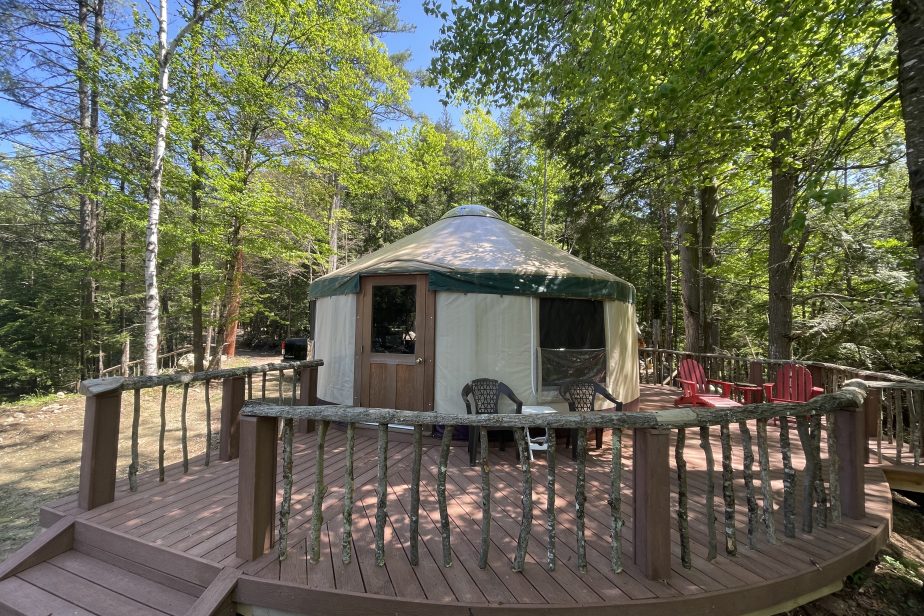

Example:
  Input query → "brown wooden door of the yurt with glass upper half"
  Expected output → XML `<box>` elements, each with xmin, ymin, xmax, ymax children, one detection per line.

<box><xmin>353</xmin><ymin>274</ymin><xmax>436</xmax><ymax>411</ymax></box>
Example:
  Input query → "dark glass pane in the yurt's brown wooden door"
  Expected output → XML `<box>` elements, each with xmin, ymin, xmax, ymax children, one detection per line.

<box><xmin>372</xmin><ymin>284</ymin><xmax>417</xmax><ymax>354</ymax></box>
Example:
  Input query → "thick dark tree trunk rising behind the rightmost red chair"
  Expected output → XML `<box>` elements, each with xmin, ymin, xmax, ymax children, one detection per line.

<box><xmin>767</xmin><ymin>129</ymin><xmax>798</xmax><ymax>359</ymax></box>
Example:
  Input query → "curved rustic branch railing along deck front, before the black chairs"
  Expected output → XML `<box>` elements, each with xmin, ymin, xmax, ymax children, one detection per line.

<box><xmin>237</xmin><ymin>380</ymin><xmax>867</xmax><ymax>579</ymax></box>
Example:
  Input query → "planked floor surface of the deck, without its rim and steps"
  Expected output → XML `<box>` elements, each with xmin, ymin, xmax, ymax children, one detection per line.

<box><xmin>30</xmin><ymin>386</ymin><xmax>891</xmax><ymax>613</ymax></box>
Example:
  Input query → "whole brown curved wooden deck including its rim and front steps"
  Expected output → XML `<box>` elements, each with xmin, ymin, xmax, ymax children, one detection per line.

<box><xmin>0</xmin><ymin>385</ymin><xmax>891</xmax><ymax>614</ymax></box>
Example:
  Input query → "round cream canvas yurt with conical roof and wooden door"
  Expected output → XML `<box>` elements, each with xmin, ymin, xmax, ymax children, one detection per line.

<box><xmin>310</xmin><ymin>205</ymin><xmax>639</xmax><ymax>414</ymax></box>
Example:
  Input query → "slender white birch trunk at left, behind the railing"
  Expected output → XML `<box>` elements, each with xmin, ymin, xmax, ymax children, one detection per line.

<box><xmin>144</xmin><ymin>0</ymin><xmax>170</xmax><ymax>376</ymax></box>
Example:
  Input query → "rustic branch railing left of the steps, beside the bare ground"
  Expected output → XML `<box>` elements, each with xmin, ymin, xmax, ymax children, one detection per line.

<box><xmin>78</xmin><ymin>360</ymin><xmax>324</xmax><ymax>509</ymax></box>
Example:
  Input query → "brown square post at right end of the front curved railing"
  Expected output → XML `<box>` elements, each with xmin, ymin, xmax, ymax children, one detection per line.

<box><xmin>834</xmin><ymin>402</ymin><xmax>879</xmax><ymax>519</ymax></box>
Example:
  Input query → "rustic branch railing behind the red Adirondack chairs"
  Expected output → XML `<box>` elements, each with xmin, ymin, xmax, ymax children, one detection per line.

<box><xmin>639</xmin><ymin>348</ymin><xmax>924</xmax><ymax>467</ymax></box>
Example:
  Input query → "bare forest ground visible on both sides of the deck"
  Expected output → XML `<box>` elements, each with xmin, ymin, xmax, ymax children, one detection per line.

<box><xmin>0</xmin><ymin>352</ymin><xmax>924</xmax><ymax>616</ymax></box>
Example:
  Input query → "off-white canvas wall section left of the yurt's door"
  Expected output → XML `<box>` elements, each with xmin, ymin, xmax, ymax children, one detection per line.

<box><xmin>314</xmin><ymin>295</ymin><xmax>358</xmax><ymax>405</ymax></box>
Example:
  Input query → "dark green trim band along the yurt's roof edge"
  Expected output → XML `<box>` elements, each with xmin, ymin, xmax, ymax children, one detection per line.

<box><xmin>309</xmin><ymin>272</ymin><xmax>635</xmax><ymax>304</ymax></box>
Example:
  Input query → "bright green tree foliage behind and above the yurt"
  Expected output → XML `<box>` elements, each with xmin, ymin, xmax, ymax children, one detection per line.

<box><xmin>0</xmin><ymin>0</ymin><xmax>921</xmax><ymax>397</ymax></box>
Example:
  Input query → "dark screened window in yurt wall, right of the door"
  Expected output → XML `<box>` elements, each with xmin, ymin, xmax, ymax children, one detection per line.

<box><xmin>539</xmin><ymin>298</ymin><xmax>606</xmax><ymax>387</ymax></box>
